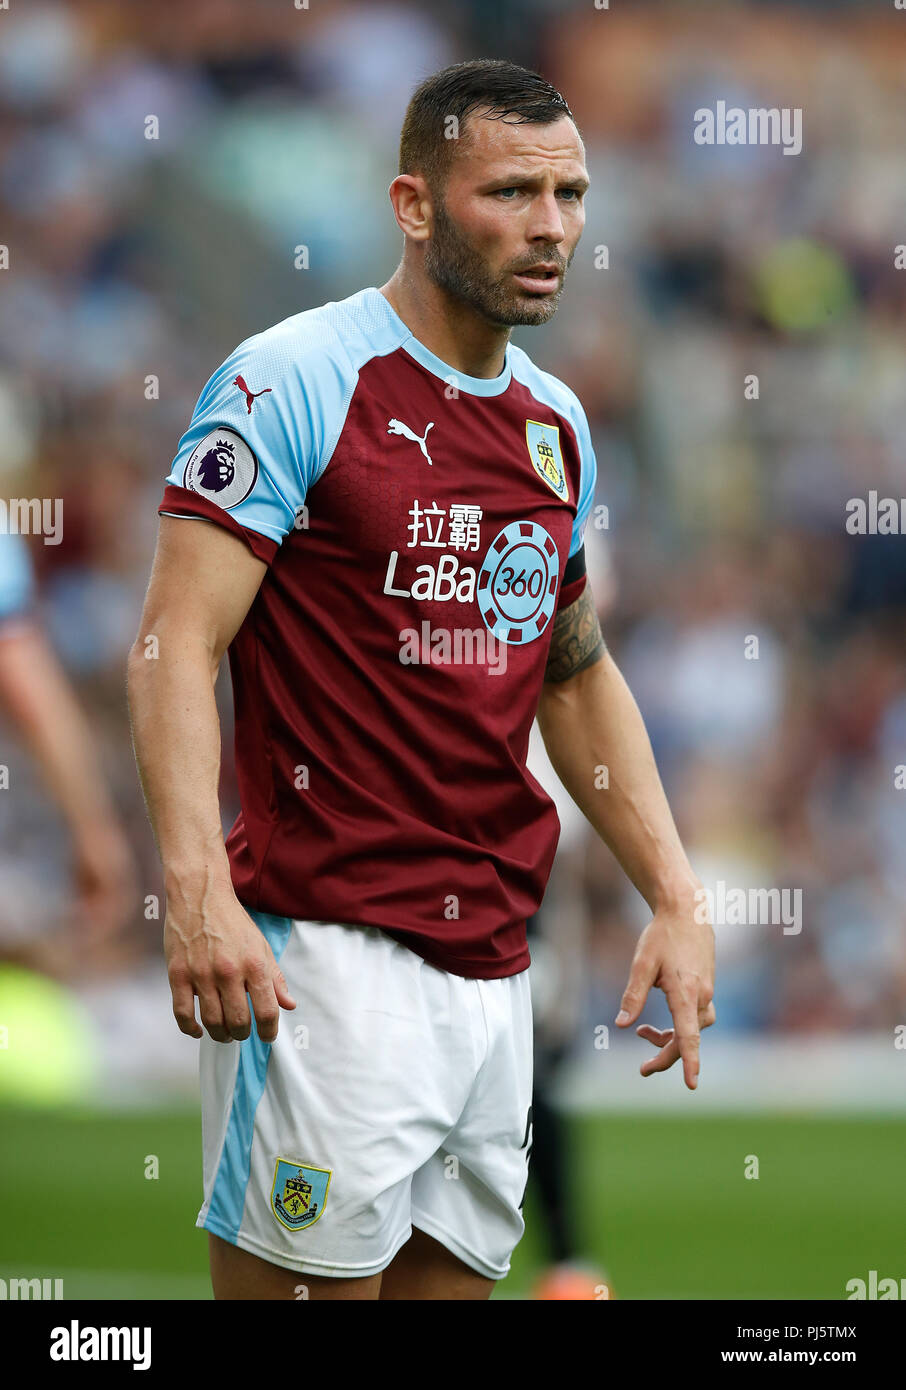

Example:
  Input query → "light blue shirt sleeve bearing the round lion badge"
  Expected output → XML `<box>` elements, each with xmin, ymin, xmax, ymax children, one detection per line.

<box><xmin>161</xmin><ymin>322</ymin><xmax>357</xmax><ymax>545</ymax></box>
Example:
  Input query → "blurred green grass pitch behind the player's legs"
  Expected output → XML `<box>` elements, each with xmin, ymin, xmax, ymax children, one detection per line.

<box><xmin>0</xmin><ymin>1109</ymin><xmax>906</xmax><ymax>1300</ymax></box>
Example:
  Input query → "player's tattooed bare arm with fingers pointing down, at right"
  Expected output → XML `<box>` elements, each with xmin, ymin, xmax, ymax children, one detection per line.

<box><xmin>538</xmin><ymin>585</ymin><xmax>714</xmax><ymax>1088</ymax></box>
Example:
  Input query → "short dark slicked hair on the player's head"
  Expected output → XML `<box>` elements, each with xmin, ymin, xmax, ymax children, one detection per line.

<box><xmin>400</xmin><ymin>58</ymin><xmax>575</xmax><ymax>192</ymax></box>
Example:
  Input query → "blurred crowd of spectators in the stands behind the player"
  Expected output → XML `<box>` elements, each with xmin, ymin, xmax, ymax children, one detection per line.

<box><xmin>0</xmin><ymin>0</ymin><xmax>906</xmax><ymax>1073</ymax></box>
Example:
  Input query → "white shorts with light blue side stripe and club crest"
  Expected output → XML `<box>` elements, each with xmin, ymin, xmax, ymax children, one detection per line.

<box><xmin>196</xmin><ymin>912</ymin><xmax>532</xmax><ymax>1279</ymax></box>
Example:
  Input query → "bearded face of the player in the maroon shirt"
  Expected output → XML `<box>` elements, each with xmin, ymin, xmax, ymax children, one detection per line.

<box><xmin>425</xmin><ymin>117</ymin><xmax>588</xmax><ymax>327</ymax></box>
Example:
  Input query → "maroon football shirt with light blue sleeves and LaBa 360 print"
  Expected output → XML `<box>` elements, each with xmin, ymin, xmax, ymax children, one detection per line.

<box><xmin>160</xmin><ymin>289</ymin><xmax>595</xmax><ymax>979</ymax></box>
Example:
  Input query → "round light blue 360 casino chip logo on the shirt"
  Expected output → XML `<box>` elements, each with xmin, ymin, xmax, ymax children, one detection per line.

<box><xmin>478</xmin><ymin>521</ymin><xmax>560</xmax><ymax>646</ymax></box>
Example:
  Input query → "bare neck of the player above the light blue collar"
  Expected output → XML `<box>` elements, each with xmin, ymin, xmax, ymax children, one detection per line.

<box><xmin>381</xmin><ymin>265</ymin><xmax>510</xmax><ymax>378</ymax></box>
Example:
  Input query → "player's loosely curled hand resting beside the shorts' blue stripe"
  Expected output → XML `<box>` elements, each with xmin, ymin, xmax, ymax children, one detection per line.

<box><xmin>164</xmin><ymin>888</ymin><xmax>296</xmax><ymax>1043</ymax></box>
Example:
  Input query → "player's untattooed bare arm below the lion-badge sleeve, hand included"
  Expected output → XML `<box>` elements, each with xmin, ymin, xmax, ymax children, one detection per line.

<box><xmin>128</xmin><ymin>516</ymin><xmax>295</xmax><ymax>1043</ymax></box>
